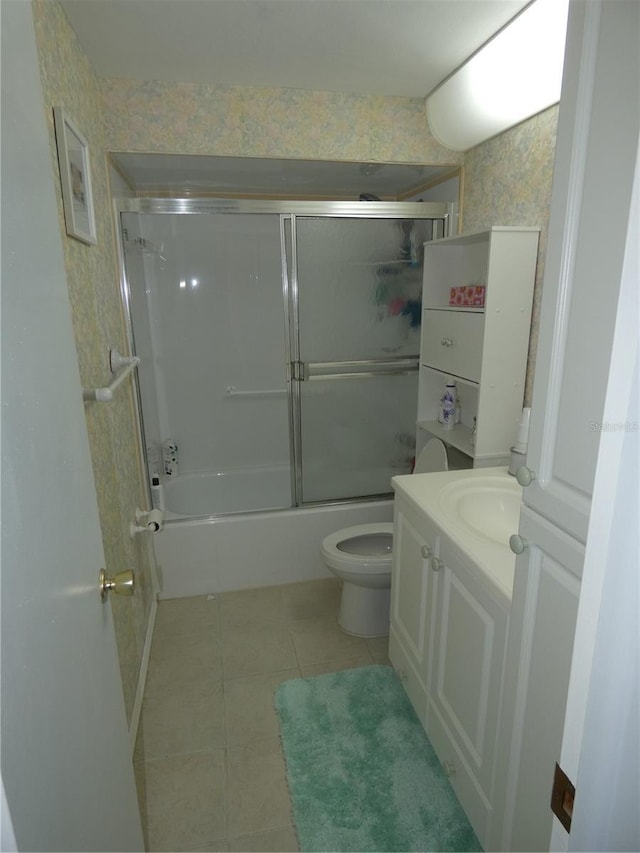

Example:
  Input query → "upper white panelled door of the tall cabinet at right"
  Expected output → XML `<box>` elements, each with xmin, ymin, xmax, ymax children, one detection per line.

<box><xmin>524</xmin><ymin>2</ymin><xmax>638</xmax><ymax>542</ymax></box>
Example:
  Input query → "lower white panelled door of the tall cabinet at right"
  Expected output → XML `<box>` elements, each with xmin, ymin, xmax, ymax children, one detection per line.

<box><xmin>489</xmin><ymin>507</ymin><xmax>584</xmax><ymax>851</ymax></box>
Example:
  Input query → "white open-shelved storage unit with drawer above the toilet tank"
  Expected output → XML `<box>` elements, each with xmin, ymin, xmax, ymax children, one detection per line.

<box><xmin>417</xmin><ymin>226</ymin><xmax>539</xmax><ymax>468</ymax></box>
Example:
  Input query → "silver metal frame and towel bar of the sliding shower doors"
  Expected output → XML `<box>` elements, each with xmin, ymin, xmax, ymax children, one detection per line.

<box><xmin>114</xmin><ymin>197</ymin><xmax>455</xmax><ymax>507</ymax></box>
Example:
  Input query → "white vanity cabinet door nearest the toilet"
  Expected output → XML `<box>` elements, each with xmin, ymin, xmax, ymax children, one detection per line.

<box><xmin>389</xmin><ymin>493</ymin><xmax>438</xmax><ymax>722</ymax></box>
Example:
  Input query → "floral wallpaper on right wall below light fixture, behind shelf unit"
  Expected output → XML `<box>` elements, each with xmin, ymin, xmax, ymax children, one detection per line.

<box><xmin>462</xmin><ymin>106</ymin><xmax>558</xmax><ymax>405</ymax></box>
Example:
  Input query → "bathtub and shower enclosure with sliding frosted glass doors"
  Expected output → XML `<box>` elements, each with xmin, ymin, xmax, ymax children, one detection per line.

<box><xmin>120</xmin><ymin>198</ymin><xmax>448</xmax><ymax>597</ymax></box>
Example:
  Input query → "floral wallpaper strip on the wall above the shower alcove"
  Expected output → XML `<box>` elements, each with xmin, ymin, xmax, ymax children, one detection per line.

<box><xmin>100</xmin><ymin>79</ymin><xmax>462</xmax><ymax>165</ymax></box>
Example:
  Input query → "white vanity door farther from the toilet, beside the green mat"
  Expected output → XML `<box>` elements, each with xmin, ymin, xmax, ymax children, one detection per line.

<box><xmin>426</xmin><ymin>540</ymin><xmax>509</xmax><ymax>846</ymax></box>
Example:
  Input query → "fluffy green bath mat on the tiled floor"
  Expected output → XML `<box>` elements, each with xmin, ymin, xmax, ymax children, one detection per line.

<box><xmin>275</xmin><ymin>666</ymin><xmax>482</xmax><ymax>853</ymax></box>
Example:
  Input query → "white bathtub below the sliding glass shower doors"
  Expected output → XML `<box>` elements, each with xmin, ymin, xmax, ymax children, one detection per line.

<box><xmin>153</xmin><ymin>471</ymin><xmax>393</xmax><ymax>598</ymax></box>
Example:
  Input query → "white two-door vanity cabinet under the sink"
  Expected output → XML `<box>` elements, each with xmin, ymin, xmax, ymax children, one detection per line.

<box><xmin>389</xmin><ymin>472</ymin><xmax>515</xmax><ymax>847</ymax></box>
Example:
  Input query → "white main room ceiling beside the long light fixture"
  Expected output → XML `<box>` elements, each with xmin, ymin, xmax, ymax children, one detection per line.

<box><xmin>62</xmin><ymin>0</ymin><xmax>529</xmax><ymax>97</ymax></box>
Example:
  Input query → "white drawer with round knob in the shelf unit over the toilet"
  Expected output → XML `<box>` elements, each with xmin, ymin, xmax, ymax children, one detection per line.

<box><xmin>420</xmin><ymin>309</ymin><xmax>484</xmax><ymax>382</ymax></box>
